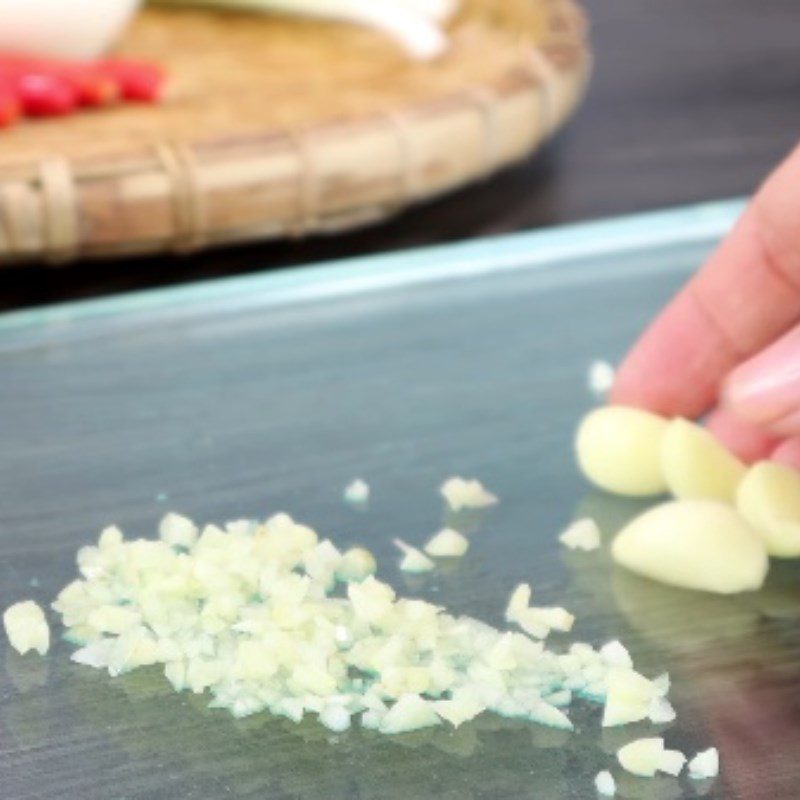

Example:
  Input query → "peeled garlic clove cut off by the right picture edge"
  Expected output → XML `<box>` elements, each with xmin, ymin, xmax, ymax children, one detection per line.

<box><xmin>736</xmin><ymin>461</ymin><xmax>800</xmax><ymax>558</ymax></box>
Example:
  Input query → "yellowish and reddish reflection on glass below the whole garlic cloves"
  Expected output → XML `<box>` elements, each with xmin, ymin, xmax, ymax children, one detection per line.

<box><xmin>564</xmin><ymin>493</ymin><xmax>800</xmax><ymax>800</ymax></box>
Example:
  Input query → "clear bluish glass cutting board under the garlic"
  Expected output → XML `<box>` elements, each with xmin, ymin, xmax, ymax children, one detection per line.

<box><xmin>0</xmin><ymin>203</ymin><xmax>800</xmax><ymax>800</ymax></box>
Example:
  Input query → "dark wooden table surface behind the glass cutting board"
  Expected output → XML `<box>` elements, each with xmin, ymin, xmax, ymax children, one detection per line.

<box><xmin>0</xmin><ymin>0</ymin><xmax>800</xmax><ymax>309</ymax></box>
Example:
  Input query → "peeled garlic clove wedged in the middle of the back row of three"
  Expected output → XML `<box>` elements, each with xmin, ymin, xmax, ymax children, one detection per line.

<box><xmin>661</xmin><ymin>419</ymin><xmax>746</xmax><ymax>503</ymax></box>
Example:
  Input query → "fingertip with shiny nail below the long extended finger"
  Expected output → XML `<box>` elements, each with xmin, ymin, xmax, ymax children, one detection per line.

<box><xmin>722</xmin><ymin>325</ymin><xmax>800</xmax><ymax>436</ymax></box>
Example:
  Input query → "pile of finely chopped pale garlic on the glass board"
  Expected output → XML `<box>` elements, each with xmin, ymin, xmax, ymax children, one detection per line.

<box><xmin>18</xmin><ymin>514</ymin><xmax>668</xmax><ymax>748</ymax></box>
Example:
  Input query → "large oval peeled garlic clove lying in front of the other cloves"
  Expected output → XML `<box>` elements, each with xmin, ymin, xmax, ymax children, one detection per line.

<box><xmin>611</xmin><ymin>500</ymin><xmax>769</xmax><ymax>594</ymax></box>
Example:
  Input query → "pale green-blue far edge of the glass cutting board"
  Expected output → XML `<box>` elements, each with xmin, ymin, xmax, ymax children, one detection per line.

<box><xmin>0</xmin><ymin>198</ymin><xmax>745</xmax><ymax>335</ymax></box>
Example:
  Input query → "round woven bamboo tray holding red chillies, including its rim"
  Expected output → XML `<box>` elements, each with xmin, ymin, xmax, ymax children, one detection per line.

<box><xmin>0</xmin><ymin>0</ymin><xmax>590</xmax><ymax>264</ymax></box>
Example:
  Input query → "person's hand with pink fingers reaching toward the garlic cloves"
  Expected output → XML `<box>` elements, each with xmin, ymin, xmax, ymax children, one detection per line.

<box><xmin>610</xmin><ymin>147</ymin><xmax>800</xmax><ymax>467</ymax></box>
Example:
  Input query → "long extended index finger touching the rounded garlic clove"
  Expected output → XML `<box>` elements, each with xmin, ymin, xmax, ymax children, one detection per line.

<box><xmin>611</xmin><ymin>147</ymin><xmax>800</xmax><ymax>417</ymax></box>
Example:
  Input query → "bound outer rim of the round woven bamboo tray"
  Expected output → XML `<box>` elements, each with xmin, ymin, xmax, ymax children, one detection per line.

<box><xmin>0</xmin><ymin>0</ymin><xmax>591</xmax><ymax>266</ymax></box>
